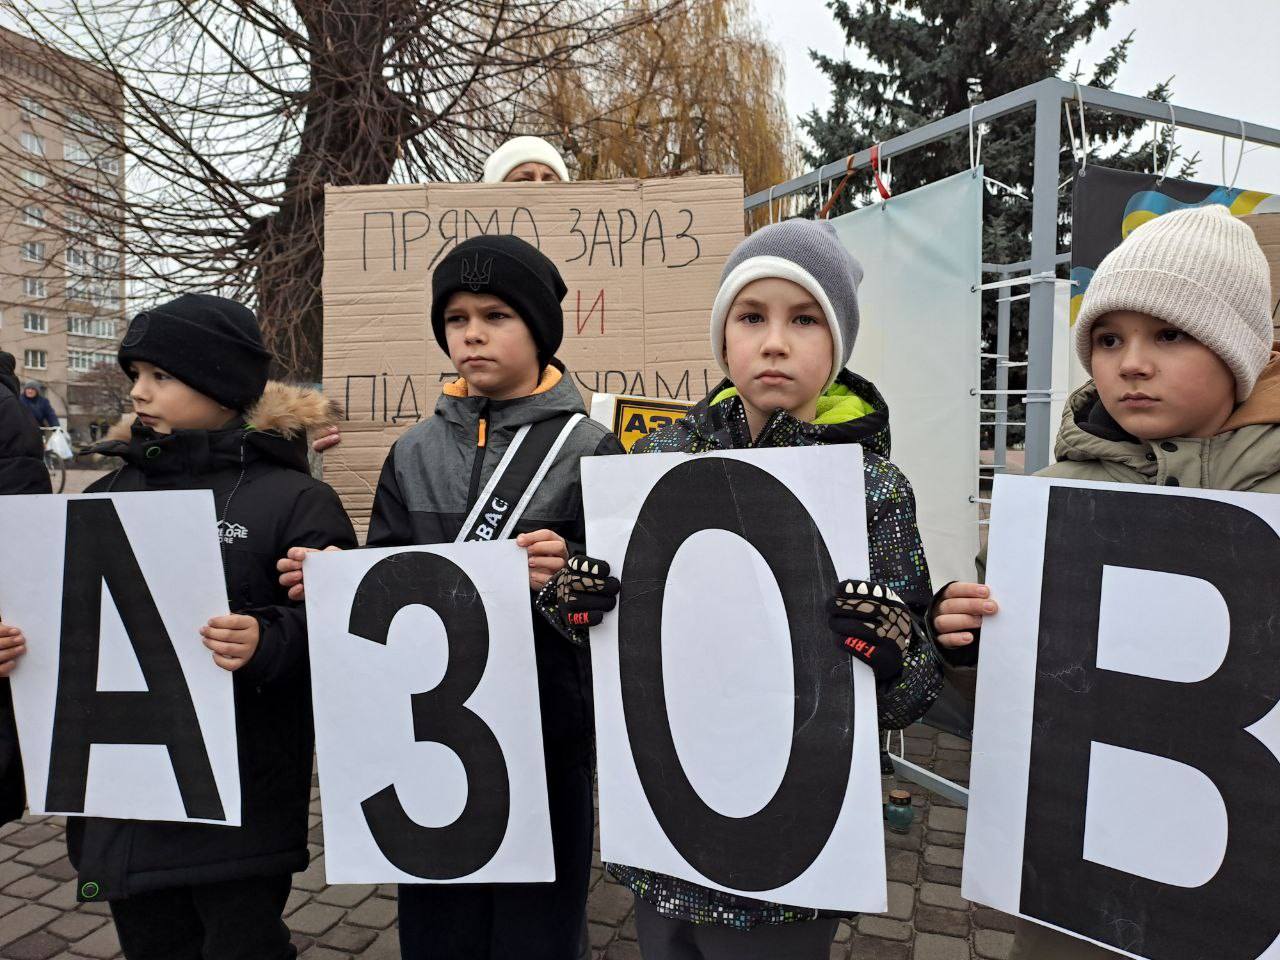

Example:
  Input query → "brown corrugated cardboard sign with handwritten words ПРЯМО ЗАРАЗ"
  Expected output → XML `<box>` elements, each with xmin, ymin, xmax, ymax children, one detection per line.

<box><xmin>324</xmin><ymin>177</ymin><xmax>742</xmax><ymax>530</ymax></box>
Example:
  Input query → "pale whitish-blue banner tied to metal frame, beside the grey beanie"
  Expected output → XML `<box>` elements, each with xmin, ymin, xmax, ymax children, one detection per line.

<box><xmin>832</xmin><ymin>168</ymin><xmax>982</xmax><ymax>586</ymax></box>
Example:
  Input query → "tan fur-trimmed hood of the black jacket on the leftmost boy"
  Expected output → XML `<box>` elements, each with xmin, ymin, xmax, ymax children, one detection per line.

<box><xmin>87</xmin><ymin>380</ymin><xmax>342</xmax><ymax>472</ymax></box>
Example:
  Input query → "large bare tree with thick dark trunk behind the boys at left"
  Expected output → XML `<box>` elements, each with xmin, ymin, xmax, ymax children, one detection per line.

<box><xmin>0</xmin><ymin>0</ymin><xmax>660</xmax><ymax>380</ymax></box>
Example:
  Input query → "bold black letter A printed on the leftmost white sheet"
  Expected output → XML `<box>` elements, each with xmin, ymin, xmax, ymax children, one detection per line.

<box><xmin>45</xmin><ymin>500</ymin><xmax>227</xmax><ymax>820</ymax></box>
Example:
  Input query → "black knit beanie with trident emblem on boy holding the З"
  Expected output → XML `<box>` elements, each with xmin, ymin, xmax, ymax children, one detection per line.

<box><xmin>431</xmin><ymin>236</ymin><xmax>567</xmax><ymax>365</ymax></box>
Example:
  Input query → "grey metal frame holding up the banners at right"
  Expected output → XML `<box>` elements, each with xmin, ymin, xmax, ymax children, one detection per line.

<box><xmin>744</xmin><ymin>77</ymin><xmax>1280</xmax><ymax>474</ymax></box>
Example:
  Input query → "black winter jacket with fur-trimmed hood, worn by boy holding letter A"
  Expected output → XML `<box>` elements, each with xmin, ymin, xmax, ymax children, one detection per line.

<box><xmin>67</xmin><ymin>383</ymin><xmax>356</xmax><ymax>900</ymax></box>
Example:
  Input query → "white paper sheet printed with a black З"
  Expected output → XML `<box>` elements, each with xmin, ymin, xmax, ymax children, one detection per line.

<box><xmin>306</xmin><ymin>540</ymin><xmax>555</xmax><ymax>883</ymax></box>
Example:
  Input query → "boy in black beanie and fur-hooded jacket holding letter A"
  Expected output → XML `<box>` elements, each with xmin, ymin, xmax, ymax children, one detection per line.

<box><xmin>1</xmin><ymin>294</ymin><xmax>356</xmax><ymax>960</ymax></box>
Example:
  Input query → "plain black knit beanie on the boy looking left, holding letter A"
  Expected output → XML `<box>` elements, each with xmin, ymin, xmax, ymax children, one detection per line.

<box><xmin>118</xmin><ymin>293</ymin><xmax>271</xmax><ymax>411</ymax></box>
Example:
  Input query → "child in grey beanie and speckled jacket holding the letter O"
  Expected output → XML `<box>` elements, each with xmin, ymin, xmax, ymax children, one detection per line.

<box><xmin>544</xmin><ymin>220</ymin><xmax>941</xmax><ymax>960</ymax></box>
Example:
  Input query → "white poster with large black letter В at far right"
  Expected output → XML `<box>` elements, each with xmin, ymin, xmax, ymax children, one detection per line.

<box><xmin>964</xmin><ymin>476</ymin><xmax>1280</xmax><ymax>960</ymax></box>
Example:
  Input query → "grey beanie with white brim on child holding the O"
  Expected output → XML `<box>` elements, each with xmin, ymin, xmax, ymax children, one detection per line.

<box><xmin>712</xmin><ymin>220</ymin><xmax>863</xmax><ymax>387</ymax></box>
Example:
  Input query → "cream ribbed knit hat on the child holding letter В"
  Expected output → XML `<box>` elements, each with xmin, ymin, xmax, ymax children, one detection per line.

<box><xmin>1075</xmin><ymin>204</ymin><xmax>1272</xmax><ymax>401</ymax></box>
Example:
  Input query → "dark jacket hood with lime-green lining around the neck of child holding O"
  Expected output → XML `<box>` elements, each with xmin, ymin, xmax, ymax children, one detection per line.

<box><xmin>677</xmin><ymin>370</ymin><xmax>891</xmax><ymax>460</ymax></box>
